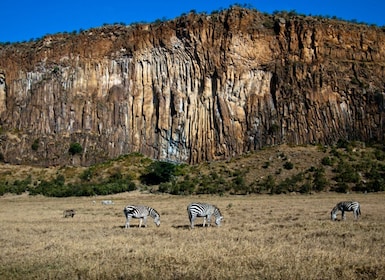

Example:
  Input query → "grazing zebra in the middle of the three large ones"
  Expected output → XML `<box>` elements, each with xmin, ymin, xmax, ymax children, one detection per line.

<box><xmin>187</xmin><ymin>203</ymin><xmax>223</xmax><ymax>228</ymax></box>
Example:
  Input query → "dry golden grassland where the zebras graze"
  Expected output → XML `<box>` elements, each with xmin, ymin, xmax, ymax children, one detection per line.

<box><xmin>0</xmin><ymin>192</ymin><xmax>385</xmax><ymax>279</ymax></box>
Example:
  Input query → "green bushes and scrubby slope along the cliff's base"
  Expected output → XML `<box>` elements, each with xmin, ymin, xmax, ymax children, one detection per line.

<box><xmin>0</xmin><ymin>140</ymin><xmax>385</xmax><ymax>197</ymax></box>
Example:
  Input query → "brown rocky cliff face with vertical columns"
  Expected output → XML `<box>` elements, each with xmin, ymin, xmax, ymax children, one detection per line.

<box><xmin>0</xmin><ymin>7</ymin><xmax>385</xmax><ymax>165</ymax></box>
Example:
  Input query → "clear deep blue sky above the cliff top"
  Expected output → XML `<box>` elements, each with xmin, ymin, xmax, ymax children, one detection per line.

<box><xmin>0</xmin><ymin>0</ymin><xmax>385</xmax><ymax>42</ymax></box>
